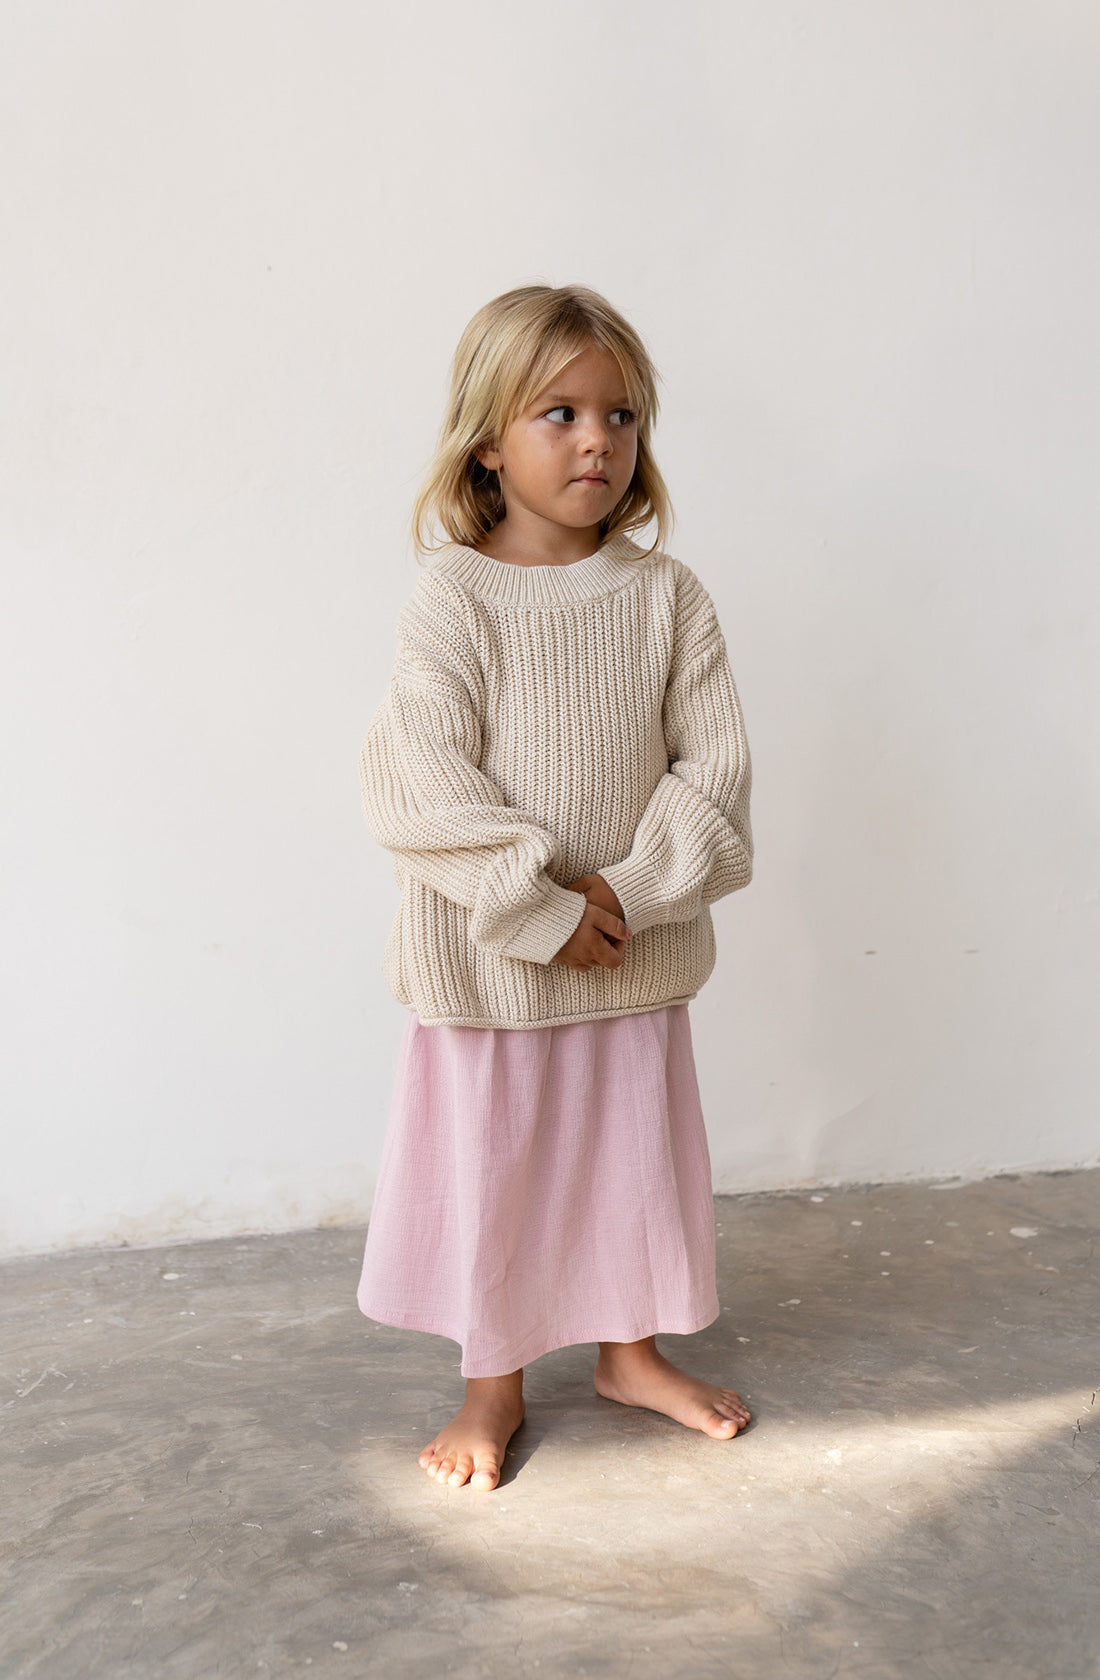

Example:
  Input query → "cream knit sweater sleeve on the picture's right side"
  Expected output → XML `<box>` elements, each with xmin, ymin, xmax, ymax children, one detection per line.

<box><xmin>598</xmin><ymin>566</ymin><xmax>752</xmax><ymax>932</ymax></box>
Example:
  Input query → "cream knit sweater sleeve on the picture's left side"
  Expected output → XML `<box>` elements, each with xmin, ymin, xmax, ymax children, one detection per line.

<box><xmin>359</xmin><ymin>571</ymin><xmax>586</xmax><ymax>963</ymax></box>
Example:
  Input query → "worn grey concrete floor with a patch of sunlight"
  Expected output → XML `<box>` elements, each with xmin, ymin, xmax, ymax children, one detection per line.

<box><xmin>0</xmin><ymin>1173</ymin><xmax>1100</xmax><ymax>1680</ymax></box>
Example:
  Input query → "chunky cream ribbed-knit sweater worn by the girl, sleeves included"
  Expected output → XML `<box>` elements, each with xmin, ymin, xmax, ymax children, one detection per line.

<box><xmin>359</xmin><ymin>536</ymin><xmax>752</xmax><ymax>1028</ymax></box>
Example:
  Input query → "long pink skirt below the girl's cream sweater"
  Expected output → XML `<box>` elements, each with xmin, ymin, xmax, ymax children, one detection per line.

<box><xmin>358</xmin><ymin>1003</ymin><xmax>719</xmax><ymax>1376</ymax></box>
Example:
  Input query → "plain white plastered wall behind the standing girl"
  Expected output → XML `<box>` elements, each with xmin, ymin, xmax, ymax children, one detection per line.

<box><xmin>0</xmin><ymin>0</ymin><xmax>1100</xmax><ymax>1252</ymax></box>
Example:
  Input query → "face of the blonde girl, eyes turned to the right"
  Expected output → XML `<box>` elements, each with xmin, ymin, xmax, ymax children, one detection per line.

<box><xmin>479</xmin><ymin>344</ymin><xmax>638</xmax><ymax>543</ymax></box>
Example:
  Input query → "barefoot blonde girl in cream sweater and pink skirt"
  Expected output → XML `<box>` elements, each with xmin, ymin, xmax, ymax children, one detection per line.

<box><xmin>358</xmin><ymin>286</ymin><xmax>752</xmax><ymax>1488</ymax></box>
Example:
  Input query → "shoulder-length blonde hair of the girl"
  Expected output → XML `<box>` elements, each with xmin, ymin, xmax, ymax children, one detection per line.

<box><xmin>411</xmin><ymin>286</ymin><xmax>672</xmax><ymax>554</ymax></box>
